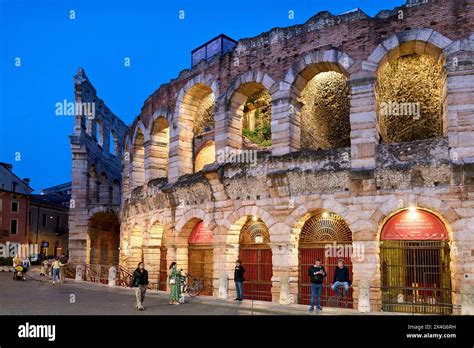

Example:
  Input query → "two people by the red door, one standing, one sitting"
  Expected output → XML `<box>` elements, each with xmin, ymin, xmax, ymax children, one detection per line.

<box><xmin>308</xmin><ymin>259</ymin><xmax>351</xmax><ymax>313</ymax></box>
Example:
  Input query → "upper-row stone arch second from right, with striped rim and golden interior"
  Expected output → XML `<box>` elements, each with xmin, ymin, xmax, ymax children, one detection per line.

<box><xmin>284</xmin><ymin>49</ymin><xmax>354</xmax><ymax>150</ymax></box>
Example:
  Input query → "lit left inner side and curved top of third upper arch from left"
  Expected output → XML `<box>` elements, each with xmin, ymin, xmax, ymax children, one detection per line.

<box><xmin>169</xmin><ymin>74</ymin><xmax>219</xmax><ymax>182</ymax></box>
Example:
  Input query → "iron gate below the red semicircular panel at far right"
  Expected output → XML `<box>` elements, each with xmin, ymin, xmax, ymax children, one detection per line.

<box><xmin>380</xmin><ymin>240</ymin><xmax>453</xmax><ymax>314</ymax></box>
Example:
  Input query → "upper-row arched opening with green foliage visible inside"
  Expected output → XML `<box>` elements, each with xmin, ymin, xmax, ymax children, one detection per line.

<box><xmin>229</xmin><ymin>82</ymin><xmax>272</xmax><ymax>149</ymax></box>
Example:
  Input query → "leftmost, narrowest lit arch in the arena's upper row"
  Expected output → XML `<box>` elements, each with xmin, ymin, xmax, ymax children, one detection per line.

<box><xmin>130</xmin><ymin>121</ymin><xmax>147</xmax><ymax>189</ymax></box>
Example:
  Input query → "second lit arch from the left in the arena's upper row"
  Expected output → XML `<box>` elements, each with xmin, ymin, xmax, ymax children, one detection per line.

<box><xmin>145</xmin><ymin>113</ymin><xmax>170</xmax><ymax>180</ymax></box>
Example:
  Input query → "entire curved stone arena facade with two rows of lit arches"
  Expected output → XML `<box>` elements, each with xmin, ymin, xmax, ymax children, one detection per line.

<box><xmin>69</xmin><ymin>0</ymin><xmax>474</xmax><ymax>314</ymax></box>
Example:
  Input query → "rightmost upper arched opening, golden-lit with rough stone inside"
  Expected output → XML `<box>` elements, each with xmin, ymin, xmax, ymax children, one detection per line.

<box><xmin>376</xmin><ymin>41</ymin><xmax>446</xmax><ymax>143</ymax></box>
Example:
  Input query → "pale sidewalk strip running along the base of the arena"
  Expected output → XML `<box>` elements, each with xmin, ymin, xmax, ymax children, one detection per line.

<box><xmin>28</xmin><ymin>267</ymin><xmax>401</xmax><ymax>315</ymax></box>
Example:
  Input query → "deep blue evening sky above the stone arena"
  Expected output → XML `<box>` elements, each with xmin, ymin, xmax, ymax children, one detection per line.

<box><xmin>0</xmin><ymin>0</ymin><xmax>405</xmax><ymax>190</ymax></box>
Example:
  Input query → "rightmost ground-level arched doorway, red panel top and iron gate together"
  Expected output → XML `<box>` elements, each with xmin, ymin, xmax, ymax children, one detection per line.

<box><xmin>380</xmin><ymin>208</ymin><xmax>452</xmax><ymax>314</ymax></box>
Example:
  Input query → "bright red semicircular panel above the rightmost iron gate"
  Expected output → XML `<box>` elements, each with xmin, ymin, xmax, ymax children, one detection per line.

<box><xmin>381</xmin><ymin>209</ymin><xmax>448</xmax><ymax>240</ymax></box>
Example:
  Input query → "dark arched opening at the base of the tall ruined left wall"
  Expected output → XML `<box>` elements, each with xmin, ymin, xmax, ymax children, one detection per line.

<box><xmin>87</xmin><ymin>212</ymin><xmax>120</xmax><ymax>266</ymax></box>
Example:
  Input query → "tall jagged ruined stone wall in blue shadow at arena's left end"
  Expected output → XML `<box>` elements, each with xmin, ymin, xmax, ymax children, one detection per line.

<box><xmin>69</xmin><ymin>68</ymin><xmax>127</xmax><ymax>264</ymax></box>
